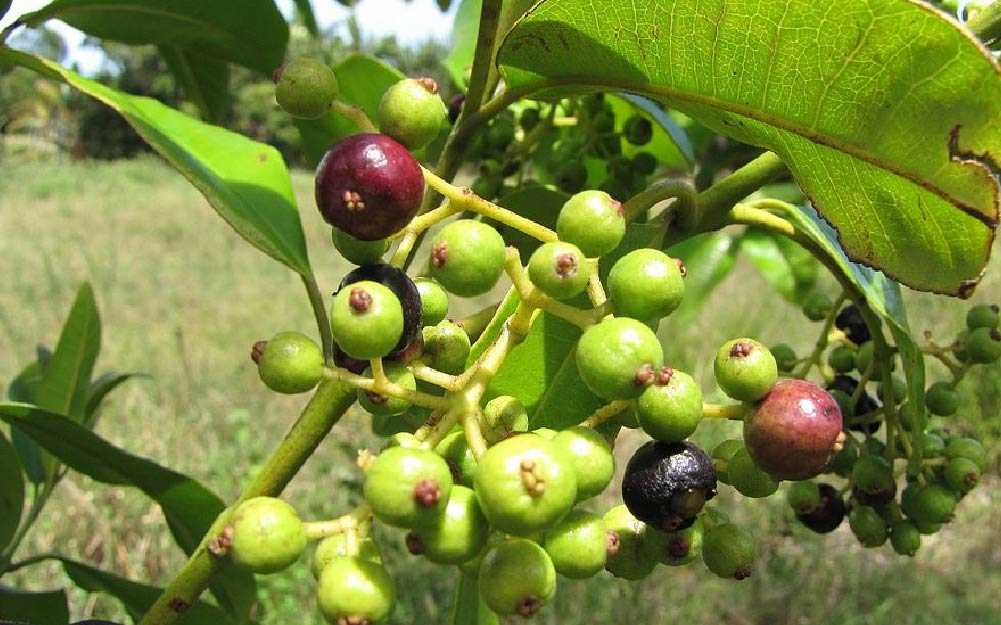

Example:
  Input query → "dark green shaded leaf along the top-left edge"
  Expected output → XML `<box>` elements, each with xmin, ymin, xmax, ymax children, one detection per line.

<box><xmin>22</xmin><ymin>0</ymin><xmax>288</xmax><ymax>74</ymax></box>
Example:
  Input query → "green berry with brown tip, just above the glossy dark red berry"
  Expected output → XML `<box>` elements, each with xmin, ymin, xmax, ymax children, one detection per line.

<box><xmin>378</xmin><ymin>78</ymin><xmax>448</xmax><ymax>150</ymax></box>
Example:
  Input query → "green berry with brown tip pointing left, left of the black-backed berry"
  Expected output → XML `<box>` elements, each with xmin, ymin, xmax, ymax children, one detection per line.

<box><xmin>251</xmin><ymin>332</ymin><xmax>323</xmax><ymax>395</ymax></box>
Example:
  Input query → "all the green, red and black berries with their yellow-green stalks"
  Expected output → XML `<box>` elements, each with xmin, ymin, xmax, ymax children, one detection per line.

<box><xmin>229</xmin><ymin>65</ymin><xmax>1001</xmax><ymax>625</ymax></box>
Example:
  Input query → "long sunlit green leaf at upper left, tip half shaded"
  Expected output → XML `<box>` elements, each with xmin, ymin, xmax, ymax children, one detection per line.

<box><xmin>0</xmin><ymin>50</ymin><xmax>310</xmax><ymax>275</ymax></box>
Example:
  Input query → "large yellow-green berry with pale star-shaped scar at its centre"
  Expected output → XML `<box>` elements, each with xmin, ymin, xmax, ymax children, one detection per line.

<box><xmin>473</xmin><ymin>434</ymin><xmax>577</xmax><ymax>536</ymax></box>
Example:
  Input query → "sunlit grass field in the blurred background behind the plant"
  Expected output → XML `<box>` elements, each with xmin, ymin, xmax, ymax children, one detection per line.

<box><xmin>0</xmin><ymin>152</ymin><xmax>1001</xmax><ymax>625</ymax></box>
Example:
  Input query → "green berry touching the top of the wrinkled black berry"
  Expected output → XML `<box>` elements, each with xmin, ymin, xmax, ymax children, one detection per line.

<box><xmin>636</xmin><ymin>368</ymin><xmax>702</xmax><ymax>443</ymax></box>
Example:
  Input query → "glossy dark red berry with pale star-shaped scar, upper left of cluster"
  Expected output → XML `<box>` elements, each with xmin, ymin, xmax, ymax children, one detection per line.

<box><xmin>315</xmin><ymin>133</ymin><xmax>424</xmax><ymax>240</ymax></box>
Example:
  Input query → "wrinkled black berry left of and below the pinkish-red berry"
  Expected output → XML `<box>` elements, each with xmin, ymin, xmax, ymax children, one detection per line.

<box><xmin>623</xmin><ymin>441</ymin><xmax>716</xmax><ymax>532</ymax></box>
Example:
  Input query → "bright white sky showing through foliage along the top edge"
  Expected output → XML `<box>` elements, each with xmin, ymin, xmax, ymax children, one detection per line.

<box><xmin>0</xmin><ymin>0</ymin><xmax>458</xmax><ymax>73</ymax></box>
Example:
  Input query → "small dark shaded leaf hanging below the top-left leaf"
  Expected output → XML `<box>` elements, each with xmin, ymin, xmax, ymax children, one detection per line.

<box><xmin>159</xmin><ymin>44</ymin><xmax>229</xmax><ymax>123</ymax></box>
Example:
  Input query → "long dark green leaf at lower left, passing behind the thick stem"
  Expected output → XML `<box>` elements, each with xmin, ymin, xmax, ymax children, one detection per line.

<box><xmin>0</xmin><ymin>403</ymin><xmax>255</xmax><ymax>618</ymax></box>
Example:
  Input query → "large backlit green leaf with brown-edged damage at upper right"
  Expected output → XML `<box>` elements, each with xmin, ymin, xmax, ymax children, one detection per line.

<box><xmin>498</xmin><ymin>0</ymin><xmax>1001</xmax><ymax>294</ymax></box>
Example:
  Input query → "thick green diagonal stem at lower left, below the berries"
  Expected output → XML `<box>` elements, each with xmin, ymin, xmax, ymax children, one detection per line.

<box><xmin>139</xmin><ymin>381</ymin><xmax>355</xmax><ymax>625</ymax></box>
